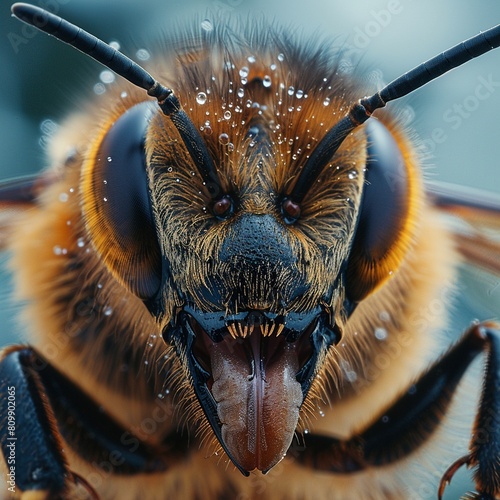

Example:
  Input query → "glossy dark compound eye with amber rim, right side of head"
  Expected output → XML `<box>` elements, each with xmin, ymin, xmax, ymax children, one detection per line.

<box><xmin>346</xmin><ymin>120</ymin><xmax>415</xmax><ymax>302</ymax></box>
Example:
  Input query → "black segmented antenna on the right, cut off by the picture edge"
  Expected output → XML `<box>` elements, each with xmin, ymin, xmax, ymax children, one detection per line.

<box><xmin>286</xmin><ymin>24</ymin><xmax>500</xmax><ymax>203</ymax></box>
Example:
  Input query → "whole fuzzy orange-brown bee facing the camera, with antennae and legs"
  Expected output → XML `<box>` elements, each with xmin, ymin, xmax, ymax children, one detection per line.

<box><xmin>0</xmin><ymin>4</ymin><xmax>500</xmax><ymax>499</ymax></box>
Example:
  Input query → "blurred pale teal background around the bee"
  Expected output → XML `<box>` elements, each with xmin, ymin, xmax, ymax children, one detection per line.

<box><xmin>0</xmin><ymin>0</ymin><xmax>500</xmax><ymax>499</ymax></box>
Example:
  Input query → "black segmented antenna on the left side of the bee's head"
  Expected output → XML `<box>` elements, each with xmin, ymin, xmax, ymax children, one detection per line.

<box><xmin>11</xmin><ymin>3</ymin><xmax>222</xmax><ymax>200</ymax></box>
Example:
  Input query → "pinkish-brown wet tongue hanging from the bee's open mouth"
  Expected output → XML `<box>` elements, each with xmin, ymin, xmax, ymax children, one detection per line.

<box><xmin>206</xmin><ymin>327</ymin><xmax>303</xmax><ymax>472</ymax></box>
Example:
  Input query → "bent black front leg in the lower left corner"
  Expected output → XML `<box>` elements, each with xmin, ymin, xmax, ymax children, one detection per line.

<box><xmin>0</xmin><ymin>346</ymin><xmax>188</xmax><ymax>499</ymax></box>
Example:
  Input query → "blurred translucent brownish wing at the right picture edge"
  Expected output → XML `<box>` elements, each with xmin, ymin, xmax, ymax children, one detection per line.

<box><xmin>426</xmin><ymin>182</ymin><xmax>500</xmax><ymax>275</ymax></box>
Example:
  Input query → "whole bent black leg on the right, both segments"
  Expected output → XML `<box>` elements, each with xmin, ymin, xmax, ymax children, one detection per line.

<box><xmin>290</xmin><ymin>324</ymin><xmax>500</xmax><ymax>500</ymax></box>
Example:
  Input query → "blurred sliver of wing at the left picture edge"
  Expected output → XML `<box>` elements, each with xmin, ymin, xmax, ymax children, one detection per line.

<box><xmin>0</xmin><ymin>173</ymin><xmax>54</xmax><ymax>250</ymax></box>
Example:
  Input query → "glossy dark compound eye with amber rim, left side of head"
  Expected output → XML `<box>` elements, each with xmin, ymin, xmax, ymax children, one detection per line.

<box><xmin>82</xmin><ymin>99</ymin><xmax>161</xmax><ymax>299</ymax></box>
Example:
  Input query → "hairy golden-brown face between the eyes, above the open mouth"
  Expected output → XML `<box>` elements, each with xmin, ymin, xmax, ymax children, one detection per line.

<box><xmin>148</xmin><ymin>56</ymin><xmax>364</xmax><ymax>314</ymax></box>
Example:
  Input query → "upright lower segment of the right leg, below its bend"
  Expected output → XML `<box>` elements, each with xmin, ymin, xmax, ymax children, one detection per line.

<box><xmin>439</xmin><ymin>325</ymin><xmax>500</xmax><ymax>500</ymax></box>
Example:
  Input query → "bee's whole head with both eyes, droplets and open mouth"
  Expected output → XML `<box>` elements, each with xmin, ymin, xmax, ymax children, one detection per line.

<box><xmin>82</xmin><ymin>42</ymin><xmax>411</xmax><ymax>471</ymax></box>
